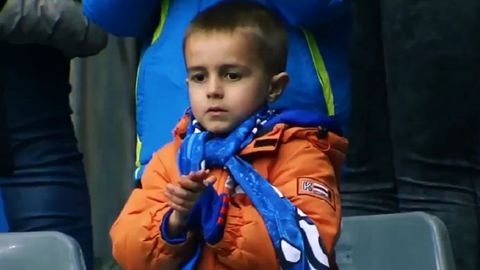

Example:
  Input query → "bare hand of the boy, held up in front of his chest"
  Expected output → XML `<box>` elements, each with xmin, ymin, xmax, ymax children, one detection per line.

<box><xmin>165</xmin><ymin>170</ymin><xmax>216</xmax><ymax>236</ymax></box>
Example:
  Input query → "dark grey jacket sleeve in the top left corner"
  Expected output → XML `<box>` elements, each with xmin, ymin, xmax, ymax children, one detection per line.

<box><xmin>0</xmin><ymin>0</ymin><xmax>107</xmax><ymax>57</ymax></box>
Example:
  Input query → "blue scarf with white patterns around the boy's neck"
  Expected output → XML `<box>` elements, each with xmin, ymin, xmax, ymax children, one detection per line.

<box><xmin>178</xmin><ymin>108</ymin><xmax>335</xmax><ymax>269</ymax></box>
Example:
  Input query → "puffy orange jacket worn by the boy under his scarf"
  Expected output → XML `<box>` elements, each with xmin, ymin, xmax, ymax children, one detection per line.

<box><xmin>110</xmin><ymin>119</ymin><xmax>347</xmax><ymax>270</ymax></box>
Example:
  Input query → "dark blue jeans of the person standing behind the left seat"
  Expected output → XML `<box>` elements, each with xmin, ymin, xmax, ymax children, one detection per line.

<box><xmin>0</xmin><ymin>44</ymin><xmax>93</xmax><ymax>269</ymax></box>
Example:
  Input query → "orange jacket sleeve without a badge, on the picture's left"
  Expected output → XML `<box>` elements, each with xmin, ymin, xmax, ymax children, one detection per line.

<box><xmin>110</xmin><ymin>150</ymin><xmax>193</xmax><ymax>270</ymax></box>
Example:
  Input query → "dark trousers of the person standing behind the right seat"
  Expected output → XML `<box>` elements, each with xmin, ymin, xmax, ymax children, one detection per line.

<box><xmin>341</xmin><ymin>0</ymin><xmax>480</xmax><ymax>270</ymax></box>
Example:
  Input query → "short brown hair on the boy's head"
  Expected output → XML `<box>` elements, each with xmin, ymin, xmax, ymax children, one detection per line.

<box><xmin>183</xmin><ymin>0</ymin><xmax>288</xmax><ymax>74</ymax></box>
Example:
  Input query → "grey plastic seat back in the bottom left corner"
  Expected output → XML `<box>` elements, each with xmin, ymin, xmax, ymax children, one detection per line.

<box><xmin>0</xmin><ymin>232</ymin><xmax>85</xmax><ymax>270</ymax></box>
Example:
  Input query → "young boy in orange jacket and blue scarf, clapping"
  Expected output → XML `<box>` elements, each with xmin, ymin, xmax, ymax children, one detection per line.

<box><xmin>111</xmin><ymin>2</ymin><xmax>347</xmax><ymax>270</ymax></box>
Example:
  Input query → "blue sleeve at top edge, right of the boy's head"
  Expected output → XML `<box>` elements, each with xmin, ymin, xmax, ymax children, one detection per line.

<box><xmin>256</xmin><ymin>0</ymin><xmax>350</xmax><ymax>28</ymax></box>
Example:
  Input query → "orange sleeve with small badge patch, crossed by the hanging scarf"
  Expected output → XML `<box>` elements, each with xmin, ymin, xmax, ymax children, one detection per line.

<box><xmin>209</xmin><ymin>137</ymin><xmax>341</xmax><ymax>269</ymax></box>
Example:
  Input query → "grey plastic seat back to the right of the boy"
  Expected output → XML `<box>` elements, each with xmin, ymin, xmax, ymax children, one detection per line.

<box><xmin>335</xmin><ymin>212</ymin><xmax>455</xmax><ymax>270</ymax></box>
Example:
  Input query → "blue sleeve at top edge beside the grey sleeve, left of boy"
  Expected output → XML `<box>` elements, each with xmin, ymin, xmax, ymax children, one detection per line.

<box><xmin>83</xmin><ymin>0</ymin><xmax>162</xmax><ymax>37</ymax></box>
